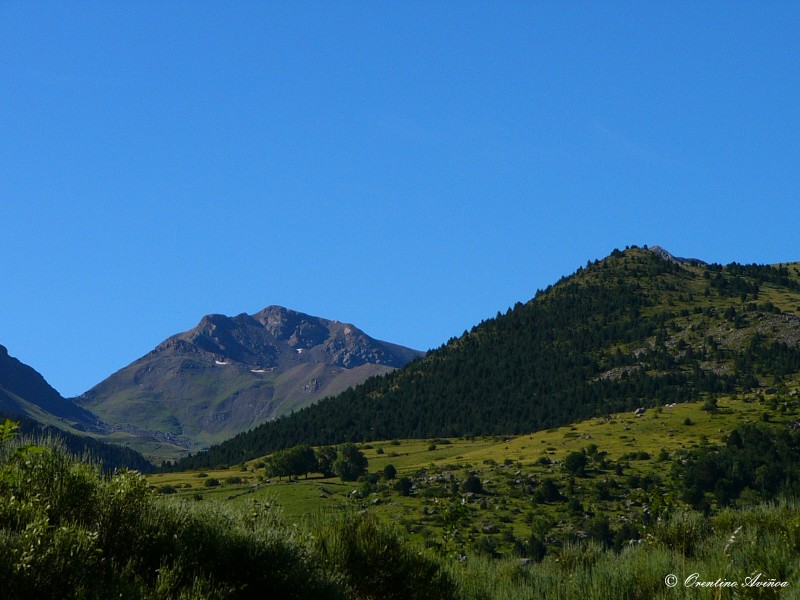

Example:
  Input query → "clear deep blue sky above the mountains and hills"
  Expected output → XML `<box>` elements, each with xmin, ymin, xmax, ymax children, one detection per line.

<box><xmin>0</xmin><ymin>1</ymin><xmax>800</xmax><ymax>396</ymax></box>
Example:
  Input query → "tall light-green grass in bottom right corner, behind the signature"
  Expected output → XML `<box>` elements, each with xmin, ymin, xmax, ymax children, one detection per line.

<box><xmin>448</xmin><ymin>503</ymin><xmax>800</xmax><ymax>600</ymax></box>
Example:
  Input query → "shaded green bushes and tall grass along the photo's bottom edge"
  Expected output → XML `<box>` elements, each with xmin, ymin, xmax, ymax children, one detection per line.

<box><xmin>0</xmin><ymin>418</ymin><xmax>800</xmax><ymax>600</ymax></box>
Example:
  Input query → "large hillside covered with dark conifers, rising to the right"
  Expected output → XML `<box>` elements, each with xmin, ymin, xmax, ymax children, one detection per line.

<box><xmin>178</xmin><ymin>247</ymin><xmax>800</xmax><ymax>468</ymax></box>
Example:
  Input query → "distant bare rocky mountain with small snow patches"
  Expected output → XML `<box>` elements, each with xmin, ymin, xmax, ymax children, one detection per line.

<box><xmin>76</xmin><ymin>306</ymin><xmax>423</xmax><ymax>456</ymax></box>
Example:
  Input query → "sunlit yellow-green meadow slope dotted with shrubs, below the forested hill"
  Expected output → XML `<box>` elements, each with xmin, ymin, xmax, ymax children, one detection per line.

<box><xmin>149</xmin><ymin>388</ymin><xmax>800</xmax><ymax>554</ymax></box>
